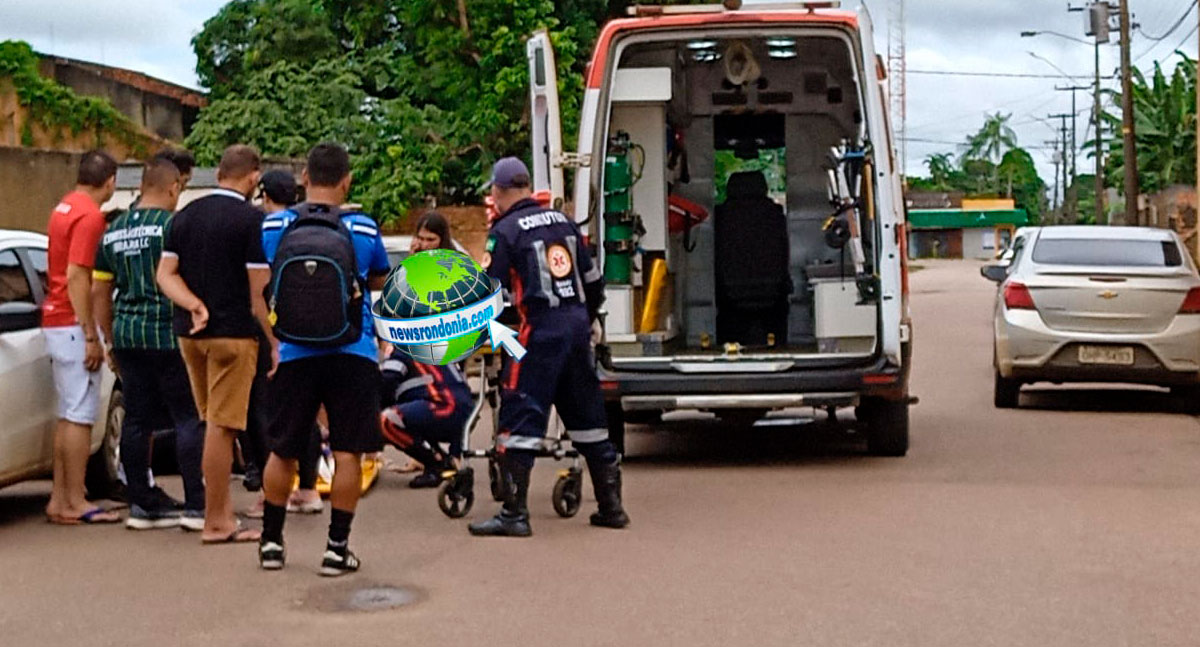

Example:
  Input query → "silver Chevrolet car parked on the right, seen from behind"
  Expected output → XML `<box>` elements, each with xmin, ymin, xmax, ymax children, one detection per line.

<box><xmin>982</xmin><ymin>227</ymin><xmax>1200</xmax><ymax>411</ymax></box>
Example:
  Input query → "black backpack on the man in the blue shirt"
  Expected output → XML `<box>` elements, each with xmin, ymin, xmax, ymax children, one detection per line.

<box><xmin>268</xmin><ymin>203</ymin><xmax>367</xmax><ymax>348</ymax></box>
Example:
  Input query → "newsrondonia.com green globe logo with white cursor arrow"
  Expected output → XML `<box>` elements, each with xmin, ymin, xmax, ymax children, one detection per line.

<box><xmin>371</xmin><ymin>250</ymin><xmax>524</xmax><ymax>366</ymax></box>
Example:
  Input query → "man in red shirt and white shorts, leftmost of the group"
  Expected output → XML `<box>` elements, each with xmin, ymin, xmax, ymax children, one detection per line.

<box><xmin>42</xmin><ymin>151</ymin><xmax>120</xmax><ymax>525</ymax></box>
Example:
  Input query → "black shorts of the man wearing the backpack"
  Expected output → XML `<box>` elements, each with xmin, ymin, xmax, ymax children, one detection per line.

<box><xmin>268</xmin><ymin>354</ymin><xmax>383</xmax><ymax>459</ymax></box>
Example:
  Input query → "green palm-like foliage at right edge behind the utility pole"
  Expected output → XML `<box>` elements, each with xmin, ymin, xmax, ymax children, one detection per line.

<box><xmin>1103</xmin><ymin>53</ymin><xmax>1196</xmax><ymax>193</ymax></box>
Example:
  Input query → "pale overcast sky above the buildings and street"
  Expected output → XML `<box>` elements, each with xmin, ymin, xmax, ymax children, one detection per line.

<box><xmin>0</xmin><ymin>0</ymin><xmax>1198</xmax><ymax>184</ymax></box>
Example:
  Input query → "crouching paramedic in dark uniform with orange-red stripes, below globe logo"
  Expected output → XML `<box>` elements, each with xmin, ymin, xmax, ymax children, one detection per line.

<box><xmin>380</xmin><ymin>353</ymin><xmax>474</xmax><ymax>487</ymax></box>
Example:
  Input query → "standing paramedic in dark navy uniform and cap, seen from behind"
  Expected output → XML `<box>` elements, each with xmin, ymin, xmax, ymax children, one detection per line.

<box><xmin>470</xmin><ymin>157</ymin><xmax>629</xmax><ymax>537</ymax></box>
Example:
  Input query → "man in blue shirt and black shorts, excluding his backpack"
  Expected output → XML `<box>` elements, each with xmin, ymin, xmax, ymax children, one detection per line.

<box><xmin>258</xmin><ymin>144</ymin><xmax>389</xmax><ymax>576</ymax></box>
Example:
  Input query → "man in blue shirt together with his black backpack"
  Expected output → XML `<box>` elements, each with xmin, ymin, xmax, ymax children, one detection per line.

<box><xmin>258</xmin><ymin>143</ymin><xmax>389</xmax><ymax>576</ymax></box>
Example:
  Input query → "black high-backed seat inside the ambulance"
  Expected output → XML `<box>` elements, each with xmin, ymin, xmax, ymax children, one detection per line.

<box><xmin>713</xmin><ymin>170</ymin><xmax>792</xmax><ymax>346</ymax></box>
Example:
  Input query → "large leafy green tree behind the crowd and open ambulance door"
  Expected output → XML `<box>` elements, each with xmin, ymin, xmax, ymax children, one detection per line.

<box><xmin>188</xmin><ymin>0</ymin><xmax>585</xmax><ymax>218</ymax></box>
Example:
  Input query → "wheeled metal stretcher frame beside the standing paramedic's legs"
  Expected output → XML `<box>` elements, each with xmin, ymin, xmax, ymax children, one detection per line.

<box><xmin>438</xmin><ymin>347</ymin><xmax>583</xmax><ymax>519</ymax></box>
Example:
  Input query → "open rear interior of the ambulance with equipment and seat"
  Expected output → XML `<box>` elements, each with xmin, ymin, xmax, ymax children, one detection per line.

<box><xmin>596</xmin><ymin>30</ymin><xmax>878</xmax><ymax>358</ymax></box>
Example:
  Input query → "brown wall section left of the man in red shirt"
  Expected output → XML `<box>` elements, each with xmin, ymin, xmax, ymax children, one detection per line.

<box><xmin>0</xmin><ymin>148</ymin><xmax>79</xmax><ymax>233</ymax></box>
